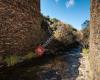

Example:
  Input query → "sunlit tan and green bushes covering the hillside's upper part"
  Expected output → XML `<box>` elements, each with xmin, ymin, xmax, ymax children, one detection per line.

<box><xmin>42</xmin><ymin>16</ymin><xmax>81</xmax><ymax>46</ymax></box>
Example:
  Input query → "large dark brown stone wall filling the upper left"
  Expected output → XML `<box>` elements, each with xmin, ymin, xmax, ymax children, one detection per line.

<box><xmin>0</xmin><ymin>0</ymin><xmax>45</xmax><ymax>54</ymax></box>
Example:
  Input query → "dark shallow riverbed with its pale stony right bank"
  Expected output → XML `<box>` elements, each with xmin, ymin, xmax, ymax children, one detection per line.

<box><xmin>0</xmin><ymin>48</ymin><xmax>89</xmax><ymax>80</ymax></box>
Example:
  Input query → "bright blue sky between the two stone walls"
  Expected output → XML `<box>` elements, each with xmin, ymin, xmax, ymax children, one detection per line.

<box><xmin>41</xmin><ymin>0</ymin><xmax>90</xmax><ymax>30</ymax></box>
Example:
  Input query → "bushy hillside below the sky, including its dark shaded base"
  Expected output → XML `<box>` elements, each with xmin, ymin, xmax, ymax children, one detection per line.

<box><xmin>42</xmin><ymin>16</ymin><xmax>82</xmax><ymax>54</ymax></box>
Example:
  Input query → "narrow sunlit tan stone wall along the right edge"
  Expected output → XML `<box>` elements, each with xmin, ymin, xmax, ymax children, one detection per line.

<box><xmin>89</xmin><ymin>0</ymin><xmax>100</xmax><ymax>80</ymax></box>
